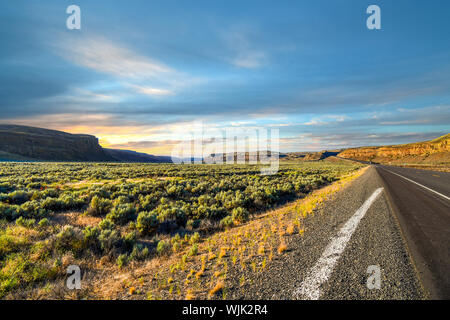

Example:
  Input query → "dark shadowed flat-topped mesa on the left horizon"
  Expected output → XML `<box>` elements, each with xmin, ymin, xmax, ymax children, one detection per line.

<box><xmin>0</xmin><ymin>124</ymin><xmax>172</xmax><ymax>163</ymax></box>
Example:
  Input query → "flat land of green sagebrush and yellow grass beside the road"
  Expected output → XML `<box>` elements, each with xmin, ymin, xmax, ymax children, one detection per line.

<box><xmin>0</xmin><ymin>161</ymin><xmax>362</xmax><ymax>299</ymax></box>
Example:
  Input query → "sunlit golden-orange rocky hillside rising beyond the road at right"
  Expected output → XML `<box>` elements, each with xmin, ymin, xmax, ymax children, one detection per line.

<box><xmin>338</xmin><ymin>133</ymin><xmax>450</xmax><ymax>164</ymax></box>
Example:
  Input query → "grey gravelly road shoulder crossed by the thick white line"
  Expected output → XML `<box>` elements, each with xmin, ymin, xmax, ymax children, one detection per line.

<box><xmin>230</xmin><ymin>166</ymin><xmax>427</xmax><ymax>300</ymax></box>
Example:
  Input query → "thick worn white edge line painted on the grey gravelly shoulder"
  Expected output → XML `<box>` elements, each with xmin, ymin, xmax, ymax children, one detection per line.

<box><xmin>294</xmin><ymin>188</ymin><xmax>383</xmax><ymax>300</ymax></box>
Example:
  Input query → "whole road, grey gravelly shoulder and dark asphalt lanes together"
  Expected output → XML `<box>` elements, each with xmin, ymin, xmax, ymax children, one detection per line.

<box><xmin>229</xmin><ymin>165</ymin><xmax>450</xmax><ymax>300</ymax></box>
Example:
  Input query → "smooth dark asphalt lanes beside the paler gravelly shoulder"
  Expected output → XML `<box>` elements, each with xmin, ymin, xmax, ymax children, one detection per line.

<box><xmin>376</xmin><ymin>165</ymin><xmax>450</xmax><ymax>299</ymax></box>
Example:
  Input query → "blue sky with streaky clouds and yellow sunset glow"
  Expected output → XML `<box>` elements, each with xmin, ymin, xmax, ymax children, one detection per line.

<box><xmin>0</xmin><ymin>0</ymin><xmax>450</xmax><ymax>155</ymax></box>
